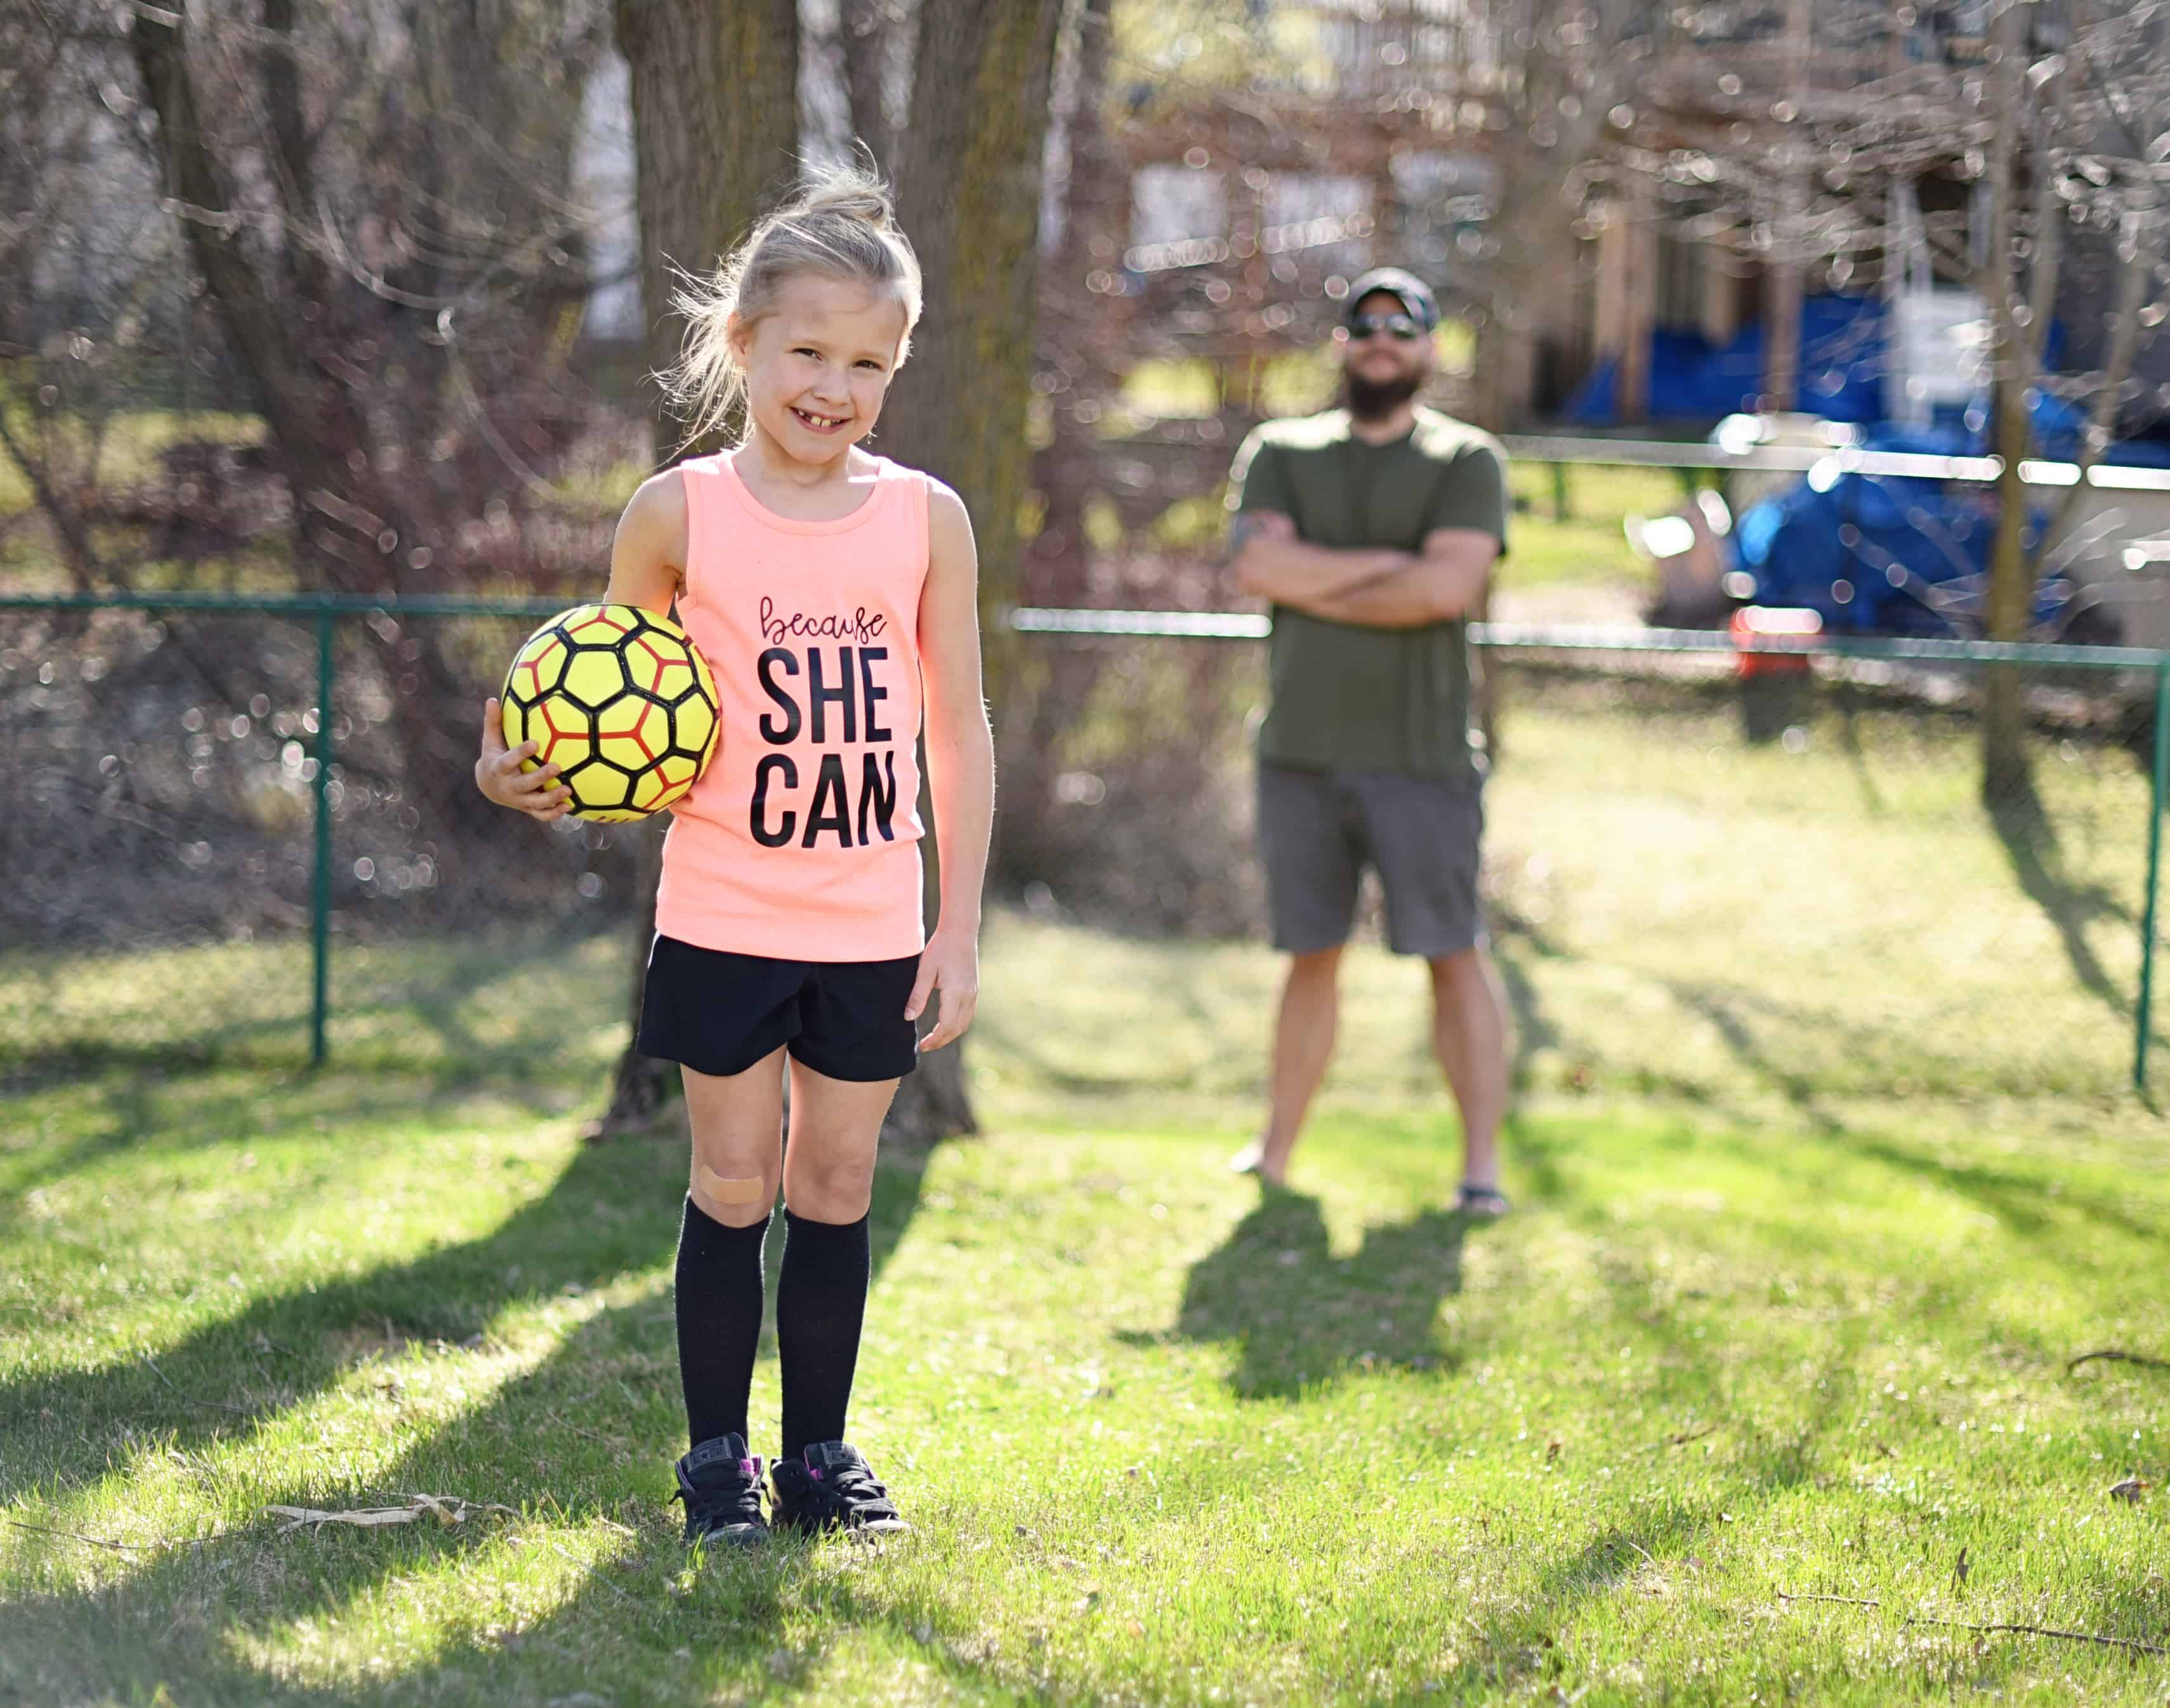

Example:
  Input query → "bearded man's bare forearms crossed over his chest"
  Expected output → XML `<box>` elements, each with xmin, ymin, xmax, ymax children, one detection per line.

<box><xmin>1228</xmin><ymin>510</ymin><xmax>1499</xmax><ymax>629</ymax></box>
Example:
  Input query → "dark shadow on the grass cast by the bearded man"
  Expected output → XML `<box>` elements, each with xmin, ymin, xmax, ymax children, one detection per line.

<box><xmin>1137</xmin><ymin>1189</ymin><xmax>1469</xmax><ymax>1400</ymax></box>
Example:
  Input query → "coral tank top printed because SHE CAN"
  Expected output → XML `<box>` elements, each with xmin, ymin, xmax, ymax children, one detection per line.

<box><xmin>655</xmin><ymin>454</ymin><xmax>926</xmax><ymax>961</ymax></box>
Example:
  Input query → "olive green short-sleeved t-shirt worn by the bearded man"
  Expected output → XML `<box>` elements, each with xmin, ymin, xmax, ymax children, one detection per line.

<box><xmin>1228</xmin><ymin>408</ymin><xmax>1506</xmax><ymax>777</ymax></box>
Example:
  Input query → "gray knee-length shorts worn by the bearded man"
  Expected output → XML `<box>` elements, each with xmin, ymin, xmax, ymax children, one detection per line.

<box><xmin>1259</xmin><ymin>764</ymin><xmax>1484</xmax><ymax>959</ymax></box>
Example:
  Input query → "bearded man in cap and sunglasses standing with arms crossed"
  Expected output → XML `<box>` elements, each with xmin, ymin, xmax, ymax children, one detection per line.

<box><xmin>1228</xmin><ymin>267</ymin><xmax>1508</xmax><ymax>1216</ymax></box>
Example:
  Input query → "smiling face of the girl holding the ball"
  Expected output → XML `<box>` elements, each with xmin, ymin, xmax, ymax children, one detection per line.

<box><xmin>732</xmin><ymin>273</ymin><xmax>907</xmax><ymax>464</ymax></box>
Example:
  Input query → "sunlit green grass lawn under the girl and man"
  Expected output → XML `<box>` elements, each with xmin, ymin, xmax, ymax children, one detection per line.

<box><xmin>0</xmin><ymin>690</ymin><xmax>2170</xmax><ymax>1708</ymax></box>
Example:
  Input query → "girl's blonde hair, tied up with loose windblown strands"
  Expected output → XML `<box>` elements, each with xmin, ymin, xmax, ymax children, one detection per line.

<box><xmin>657</xmin><ymin>161</ymin><xmax>920</xmax><ymax>443</ymax></box>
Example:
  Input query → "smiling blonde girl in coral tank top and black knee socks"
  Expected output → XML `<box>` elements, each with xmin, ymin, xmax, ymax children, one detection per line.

<box><xmin>475</xmin><ymin>169</ymin><xmax>994</xmax><ymax>1543</ymax></box>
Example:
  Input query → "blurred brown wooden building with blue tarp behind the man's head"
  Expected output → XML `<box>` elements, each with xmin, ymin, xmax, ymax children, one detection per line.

<box><xmin>1055</xmin><ymin>0</ymin><xmax>2152</xmax><ymax>425</ymax></box>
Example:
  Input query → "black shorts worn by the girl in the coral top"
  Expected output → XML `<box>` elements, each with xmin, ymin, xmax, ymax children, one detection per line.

<box><xmin>638</xmin><ymin>935</ymin><xmax>920</xmax><ymax>1081</ymax></box>
